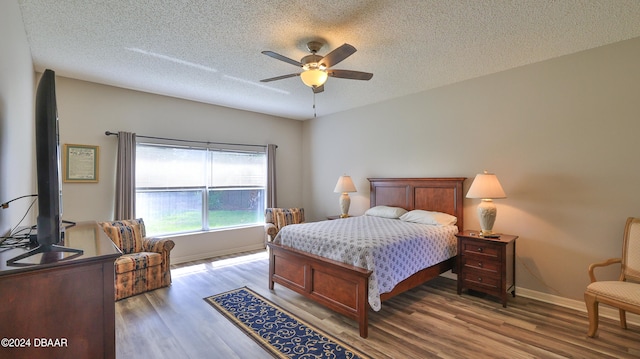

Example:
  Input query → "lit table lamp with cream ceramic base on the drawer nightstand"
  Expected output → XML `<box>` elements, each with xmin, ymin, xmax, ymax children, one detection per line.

<box><xmin>467</xmin><ymin>171</ymin><xmax>507</xmax><ymax>236</ymax></box>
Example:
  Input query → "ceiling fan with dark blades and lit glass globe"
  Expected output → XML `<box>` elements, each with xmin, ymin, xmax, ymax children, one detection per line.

<box><xmin>260</xmin><ymin>41</ymin><xmax>373</xmax><ymax>93</ymax></box>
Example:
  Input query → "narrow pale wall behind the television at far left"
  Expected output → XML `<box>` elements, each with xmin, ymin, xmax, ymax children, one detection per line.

<box><xmin>0</xmin><ymin>1</ymin><xmax>36</xmax><ymax>236</ymax></box>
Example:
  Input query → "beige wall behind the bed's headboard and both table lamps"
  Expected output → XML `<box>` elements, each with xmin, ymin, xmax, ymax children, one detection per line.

<box><xmin>304</xmin><ymin>38</ymin><xmax>640</xmax><ymax>300</ymax></box>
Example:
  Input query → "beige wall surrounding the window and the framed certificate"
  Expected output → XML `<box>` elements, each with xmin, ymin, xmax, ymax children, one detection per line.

<box><xmin>54</xmin><ymin>78</ymin><xmax>302</xmax><ymax>263</ymax></box>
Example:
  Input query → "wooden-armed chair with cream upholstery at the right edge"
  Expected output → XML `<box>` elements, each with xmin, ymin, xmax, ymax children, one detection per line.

<box><xmin>584</xmin><ymin>218</ymin><xmax>640</xmax><ymax>337</ymax></box>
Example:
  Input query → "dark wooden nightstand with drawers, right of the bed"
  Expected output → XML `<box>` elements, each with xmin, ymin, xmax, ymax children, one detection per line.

<box><xmin>456</xmin><ymin>231</ymin><xmax>518</xmax><ymax>308</ymax></box>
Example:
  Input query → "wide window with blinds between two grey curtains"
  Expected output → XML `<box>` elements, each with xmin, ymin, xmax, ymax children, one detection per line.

<box><xmin>136</xmin><ymin>143</ymin><xmax>267</xmax><ymax>235</ymax></box>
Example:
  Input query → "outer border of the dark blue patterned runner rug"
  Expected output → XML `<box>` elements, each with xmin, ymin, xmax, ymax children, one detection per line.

<box><xmin>203</xmin><ymin>286</ymin><xmax>370</xmax><ymax>359</ymax></box>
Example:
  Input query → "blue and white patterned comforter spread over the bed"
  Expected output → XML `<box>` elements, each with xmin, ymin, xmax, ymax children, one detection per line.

<box><xmin>274</xmin><ymin>216</ymin><xmax>458</xmax><ymax>311</ymax></box>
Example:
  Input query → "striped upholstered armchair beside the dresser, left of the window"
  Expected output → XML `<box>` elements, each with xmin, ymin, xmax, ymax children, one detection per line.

<box><xmin>100</xmin><ymin>218</ymin><xmax>175</xmax><ymax>300</ymax></box>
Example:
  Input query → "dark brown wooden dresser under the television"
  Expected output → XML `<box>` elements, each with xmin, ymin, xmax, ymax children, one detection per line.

<box><xmin>0</xmin><ymin>222</ymin><xmax>121</xmax><ymax>358</ymax></box>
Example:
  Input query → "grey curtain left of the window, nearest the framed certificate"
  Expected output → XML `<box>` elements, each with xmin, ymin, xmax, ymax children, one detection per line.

<box><xmin>114</xmin><ymin>131</ymin><xmax>136</xmax><ymax>220</ymax></box>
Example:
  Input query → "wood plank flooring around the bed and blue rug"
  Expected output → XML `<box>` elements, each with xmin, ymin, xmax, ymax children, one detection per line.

<box><xmin>116</xmin><ymin>251</ymin><xmax>640</xmax><ymax>359</ymax></box>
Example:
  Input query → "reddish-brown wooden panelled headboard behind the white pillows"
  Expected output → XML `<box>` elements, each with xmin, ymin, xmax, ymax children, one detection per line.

<box><xmin>368</xmin><ymin>177</ymin><xmax>466</xmax><ymax>230</ymax></box>
